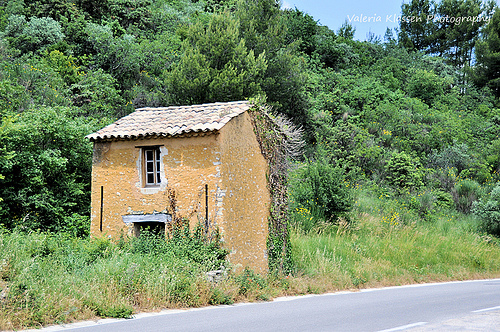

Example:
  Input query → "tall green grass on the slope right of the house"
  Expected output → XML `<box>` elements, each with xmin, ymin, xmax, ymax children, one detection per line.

<box><xmin>291</xmin><ymin>191</ymin><xmax>500</xmax><ymax>292</ymax></box>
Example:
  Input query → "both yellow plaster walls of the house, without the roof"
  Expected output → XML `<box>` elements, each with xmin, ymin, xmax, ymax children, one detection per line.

<box><xmin>91</xmin><ymin>113</ymin><xmax>270</xmax><ymax>272</ymax></box>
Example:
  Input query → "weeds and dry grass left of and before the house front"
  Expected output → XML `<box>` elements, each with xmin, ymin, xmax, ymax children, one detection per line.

<box><xmin>0</xmin><ymin>229</ymin><xmax>229</xmax><ymax>330</ymax></box>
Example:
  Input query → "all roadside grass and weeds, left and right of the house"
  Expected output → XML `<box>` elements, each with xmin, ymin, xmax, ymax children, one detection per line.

<box><xmin>0</xmin><ymin>189</ymin><xmax>500</xmax><ymax>330</ymax></box>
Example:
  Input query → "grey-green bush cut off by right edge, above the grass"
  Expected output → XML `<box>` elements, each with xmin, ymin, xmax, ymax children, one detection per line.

<box><xmin>472</xmin><ymin>182</ymin><xmax>500</xmax><ymax>236</ymax></box>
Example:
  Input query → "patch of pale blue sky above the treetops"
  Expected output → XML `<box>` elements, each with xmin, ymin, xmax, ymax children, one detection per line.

<box><xmin>282</xmin><ymin>0</ymin><xmax>408</xmax><ymax>41</ymax></box>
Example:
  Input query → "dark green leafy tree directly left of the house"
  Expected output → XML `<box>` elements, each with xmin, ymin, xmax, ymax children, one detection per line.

<box><xmin>0</xmin><ymin>108</ymin><xmax>99</xmax><ymax>236</ymax></box>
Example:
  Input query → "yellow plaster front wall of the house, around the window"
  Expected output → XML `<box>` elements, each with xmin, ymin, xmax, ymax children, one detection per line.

<box><xmin>91</xmin><ymin>135</ymin><xmax>222</xmax><ymax>237</ymax></box>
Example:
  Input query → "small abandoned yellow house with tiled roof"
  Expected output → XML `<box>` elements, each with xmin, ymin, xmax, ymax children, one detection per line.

<box><xmin>87</xmin><ymin>101</ymin><xmax>270</xmax><ymax>272</ymax></box>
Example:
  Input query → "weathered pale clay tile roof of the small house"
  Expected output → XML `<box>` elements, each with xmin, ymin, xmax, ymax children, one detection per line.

<box><xmin>87</xmin><ymin>101</ymin><xmax>252</xmax><ymax>141</ymax></box>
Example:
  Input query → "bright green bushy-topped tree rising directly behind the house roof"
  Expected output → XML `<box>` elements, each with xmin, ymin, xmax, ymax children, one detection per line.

<box><xmin>166</xmin><ymin>12</ymin><xmax>267</xmax><ymax>104</ymax></box>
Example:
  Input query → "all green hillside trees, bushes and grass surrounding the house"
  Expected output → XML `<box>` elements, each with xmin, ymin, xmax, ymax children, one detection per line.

<box><xmin>0</xmin><ymin>0</ymin><xmax>500</xmax><ymax>329</ymax></box>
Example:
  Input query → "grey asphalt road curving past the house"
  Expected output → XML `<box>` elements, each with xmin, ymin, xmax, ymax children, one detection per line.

<box><xmin>38</xmin><ymin>279</ymin><xmax>500</xmax><ymax>332</ymax></box>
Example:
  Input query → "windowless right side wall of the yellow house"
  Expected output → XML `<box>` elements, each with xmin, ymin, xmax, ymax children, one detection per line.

<box><xmin>220</xmin><ymin>113</ymin><xmax>270</xmax><ymax>272</ymax></box>
